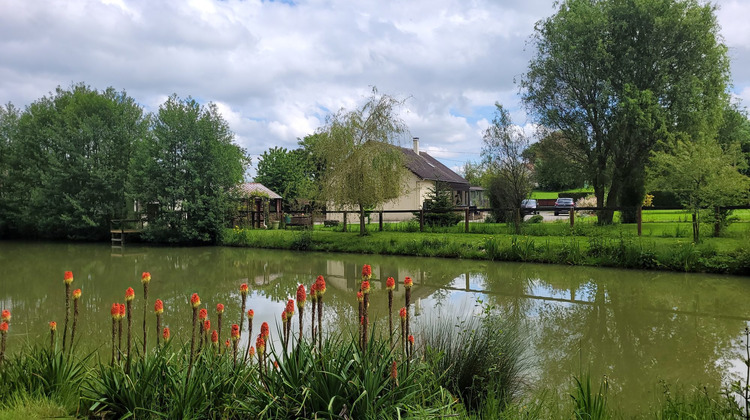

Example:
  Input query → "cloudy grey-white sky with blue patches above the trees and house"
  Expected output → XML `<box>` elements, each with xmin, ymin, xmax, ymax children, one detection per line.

<box><xmin>0</xmin><ymin>0</ymin><xmax>750</xmax><ymax>175</ymax></box>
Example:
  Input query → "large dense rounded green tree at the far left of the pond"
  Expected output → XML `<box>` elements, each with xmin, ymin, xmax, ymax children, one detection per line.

<box><xmin>3</xmin><ymin>84</ymin><xmax>147</xmax><ymax>239</ymax></box>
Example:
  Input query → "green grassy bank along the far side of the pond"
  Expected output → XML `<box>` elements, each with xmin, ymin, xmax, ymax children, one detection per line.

<box><xmin>224</xmin><ymin>223</ymin><xmax>750</xmax><ymax>275</ymax></box>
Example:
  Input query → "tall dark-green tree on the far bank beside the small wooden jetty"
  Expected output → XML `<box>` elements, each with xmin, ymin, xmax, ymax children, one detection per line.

<box><xmin>130</xmin><ymin>95</ymin><xmax>249</xmax><ymax>244</ymax></box>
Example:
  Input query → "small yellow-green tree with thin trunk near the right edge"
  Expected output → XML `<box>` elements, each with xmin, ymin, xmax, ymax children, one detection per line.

<box><xmin>649</xmin><ymin>139</ymin><xmax>750</xmax><ymax>243</ymax></box>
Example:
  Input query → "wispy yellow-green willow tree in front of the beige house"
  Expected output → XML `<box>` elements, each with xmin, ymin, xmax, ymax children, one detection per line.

<box><xmin>314</xmin><ymin>88</ymin><xmax>408</xmax><ymax>235</ymax></box>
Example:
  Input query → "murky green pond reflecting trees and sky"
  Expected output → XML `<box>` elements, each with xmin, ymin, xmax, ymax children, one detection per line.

<box><xmin>0</xmin><ymin>241</ymin><xmax>750</xmax><ymax>413</ymax></box>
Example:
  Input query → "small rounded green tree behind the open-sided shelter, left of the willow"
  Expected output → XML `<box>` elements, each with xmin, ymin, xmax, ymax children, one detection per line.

<box><xmin>255</xmin><ymin>147</ymin><xmax>313</xmax><ymax>210</ymax></box>
